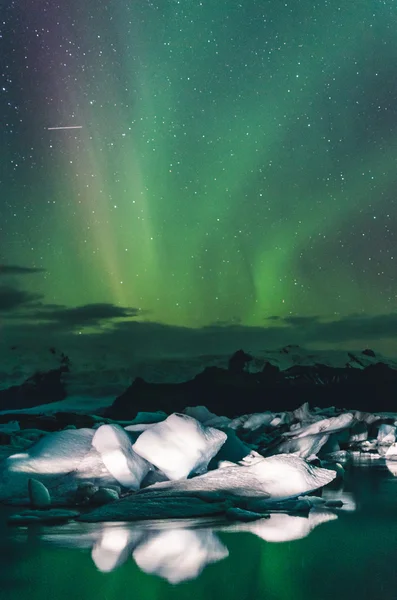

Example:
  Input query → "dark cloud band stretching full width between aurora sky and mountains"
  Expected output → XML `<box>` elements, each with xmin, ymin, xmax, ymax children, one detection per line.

<box><xmin>0</xmin><ymin>286</ymin><xmax>397</xmax><ymax>357</ymax></box>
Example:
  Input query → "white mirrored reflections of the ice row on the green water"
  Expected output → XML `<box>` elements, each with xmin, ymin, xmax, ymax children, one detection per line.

<box><xmin>36</xmin><ymin>508</ymin><xmax>338</xmax><ymax>584</ymax></box>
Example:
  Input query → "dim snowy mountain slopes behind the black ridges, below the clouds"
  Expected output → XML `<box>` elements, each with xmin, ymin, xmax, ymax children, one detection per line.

<box><xmin>0</xmin><ymin>345</ymin><xmax>397</xmax><ymax>408</ymax></box>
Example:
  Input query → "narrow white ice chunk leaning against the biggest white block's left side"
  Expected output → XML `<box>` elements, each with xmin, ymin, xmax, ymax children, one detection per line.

<box><xmin>92</xmin><ymin>425</ymin><xmax>150</xmax><ymax>490</ymax></box>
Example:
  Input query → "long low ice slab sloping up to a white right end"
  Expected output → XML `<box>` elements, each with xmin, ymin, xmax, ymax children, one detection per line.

<box><xmin>81</xmin><ymin>452</ymin><xmax>336</xmax><ymax>521</ymax></box>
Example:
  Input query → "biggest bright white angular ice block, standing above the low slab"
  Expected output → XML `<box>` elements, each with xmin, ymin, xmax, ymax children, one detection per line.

<box><xmin>133</xmin><ymin>413</ymin><xmax>227</xmax><ymax>480</ymax></box>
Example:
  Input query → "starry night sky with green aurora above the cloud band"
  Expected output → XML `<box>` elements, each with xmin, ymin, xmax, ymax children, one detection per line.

<box><xmin>0</xmin><ymin>0</ymin><xmax>397</xmax><ymax>354</ymax></box>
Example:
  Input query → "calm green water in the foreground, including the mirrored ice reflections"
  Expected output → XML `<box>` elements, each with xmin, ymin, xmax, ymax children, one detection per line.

<box><xmin>0</xmin><ymin>468</ymin><xmax>397</xmax><ymax>600</ymax></box>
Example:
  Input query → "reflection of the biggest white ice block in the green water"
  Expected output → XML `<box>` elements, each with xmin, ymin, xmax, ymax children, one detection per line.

<box><xmin>132</xmin><ymin>529</ymin><xmax>229</xmax><ymax>584</ymax></box>
